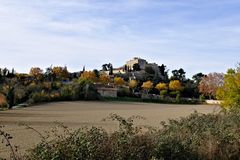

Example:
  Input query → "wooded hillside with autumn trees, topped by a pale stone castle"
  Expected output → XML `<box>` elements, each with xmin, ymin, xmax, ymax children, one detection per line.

<box><xmin>0</xmin><ymin>57</ymin><xmax>211</xmax><ymax>108</ymax></box>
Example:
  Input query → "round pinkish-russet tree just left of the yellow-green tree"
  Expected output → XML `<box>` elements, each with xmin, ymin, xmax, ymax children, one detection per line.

<box><xmin>198</xmin><ymin>73</ymin><xmax>224</xmax><ymax>99</ymax></box>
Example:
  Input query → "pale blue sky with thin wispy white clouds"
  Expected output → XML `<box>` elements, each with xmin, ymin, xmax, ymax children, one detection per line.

<box><xmin>0</xmin><ymin>0</ymin><xmax>240</xmax><ymax>77</ymax></box>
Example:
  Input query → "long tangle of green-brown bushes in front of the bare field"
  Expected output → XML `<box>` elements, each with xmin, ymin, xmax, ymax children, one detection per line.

<box><xmin>20</xmin><ymin>111</ymin><xmax>240</xmax><ymax>160</ymax></box>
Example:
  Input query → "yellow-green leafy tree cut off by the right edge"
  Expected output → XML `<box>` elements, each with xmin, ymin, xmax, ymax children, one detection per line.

<box><xmin>216</xmin><ymin>68</ymin><xmax>240</xmax><ymax>109</ymax></box>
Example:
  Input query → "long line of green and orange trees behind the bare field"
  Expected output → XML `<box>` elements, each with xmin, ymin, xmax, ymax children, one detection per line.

<box><xmin>0</xmin><ymin>63</ymin><xmax>239</xmax><ymax>108</ymax></box>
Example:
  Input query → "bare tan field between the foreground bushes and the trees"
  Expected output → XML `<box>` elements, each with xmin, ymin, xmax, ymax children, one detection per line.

<box><xmin>0</xmin><ymin>102</ymin><xmax>219</xmax><ymax>157</ymax></box>
